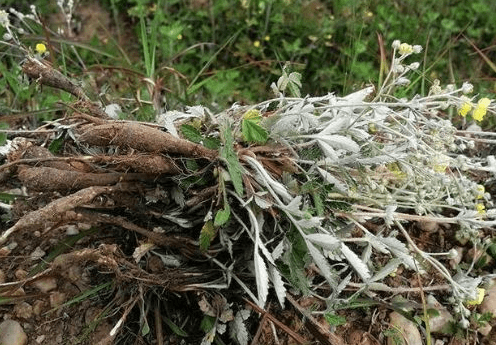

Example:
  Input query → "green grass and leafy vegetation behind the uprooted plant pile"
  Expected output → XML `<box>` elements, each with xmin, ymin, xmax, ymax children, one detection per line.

<box><xmin>0</xmin><ymin>0</ymin><xmax>496</xmax><ymax>118</ymax></box>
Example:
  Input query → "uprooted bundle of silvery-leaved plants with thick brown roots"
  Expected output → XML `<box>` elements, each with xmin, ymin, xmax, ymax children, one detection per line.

<box><xmin>0</xmin><ymin>6</ymin><xmax>496</xmax><ymax>344</ymax></box>
